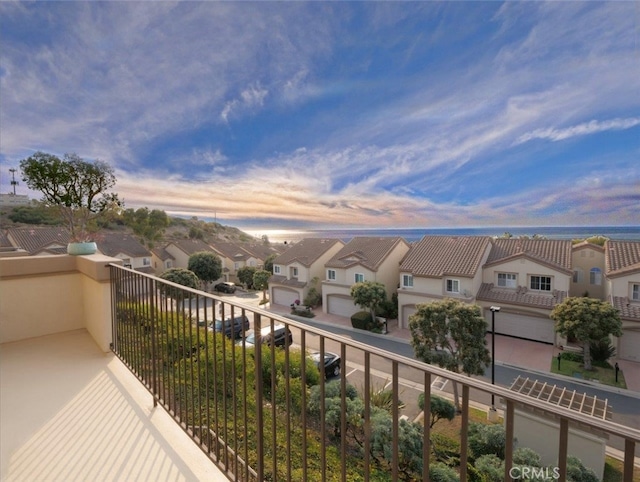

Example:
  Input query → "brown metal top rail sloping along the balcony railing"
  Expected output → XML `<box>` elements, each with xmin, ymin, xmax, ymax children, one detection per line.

<box><xmin>109</xmin><ymin>263</ymin><xmax>640</xmax><ymax>443</ymax></box>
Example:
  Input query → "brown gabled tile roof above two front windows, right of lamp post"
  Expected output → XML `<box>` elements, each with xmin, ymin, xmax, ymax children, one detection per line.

<box><xmin>486</xmin><ymin>238</ymin><xmax>572</xmax><ymax>273</ymax></box>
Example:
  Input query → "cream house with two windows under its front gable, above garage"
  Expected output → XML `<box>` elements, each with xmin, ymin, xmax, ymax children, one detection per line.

<box><xmin>476</xmin><ymin>238</ymin><xmax>573</xmax><ymax>344</ymax></box>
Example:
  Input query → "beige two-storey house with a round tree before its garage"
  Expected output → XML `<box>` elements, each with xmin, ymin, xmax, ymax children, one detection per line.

<box><xmin>322</xmin><ymin>237</ymin><xmax>410</xmax><ymax>317</ymax></box>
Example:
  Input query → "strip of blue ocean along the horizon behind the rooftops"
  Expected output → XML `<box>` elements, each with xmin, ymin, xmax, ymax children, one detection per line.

<box><xmin>247</xmin><ymin>226</ymin><xmax>640</xmax><ymax>243</ymax></box>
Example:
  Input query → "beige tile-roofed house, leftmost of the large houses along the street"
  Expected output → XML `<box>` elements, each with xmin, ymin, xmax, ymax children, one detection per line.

<box><xmin>269</xmin><ymin>238</ymin><xmax>344</xmax><ymax>305</ymax></box>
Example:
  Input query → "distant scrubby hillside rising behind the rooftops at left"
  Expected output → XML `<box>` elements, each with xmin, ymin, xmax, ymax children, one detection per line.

<box><xmin>0</xmin><ymin>205</ymin><xmax>262</xmax><ymax>245</ymax></box>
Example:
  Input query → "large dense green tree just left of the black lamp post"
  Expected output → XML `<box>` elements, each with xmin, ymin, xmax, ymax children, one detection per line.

<box><xmin>409</xmin><ymin>298</ymin><xmax>491</xmax><ymax>410</ymax></box>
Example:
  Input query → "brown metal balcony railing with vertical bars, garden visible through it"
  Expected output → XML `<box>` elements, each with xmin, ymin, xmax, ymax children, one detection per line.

<box><xmin>111</xmin><ymin>265</ymin><xmax>640</xmax><ymax>482</ymax></box>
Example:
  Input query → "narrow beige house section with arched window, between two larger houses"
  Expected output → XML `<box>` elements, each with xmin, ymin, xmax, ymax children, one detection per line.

<box><xmin>569</xmin><ymin>241</ymin><xmax>605</xmax><ymax>300</ymax></box>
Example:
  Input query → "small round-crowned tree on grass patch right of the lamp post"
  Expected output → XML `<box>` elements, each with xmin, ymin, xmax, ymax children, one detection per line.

<box><xmin>550</xmin><ymin>297</ymin><xmax>622</xmax><ymax>370</ymax></box>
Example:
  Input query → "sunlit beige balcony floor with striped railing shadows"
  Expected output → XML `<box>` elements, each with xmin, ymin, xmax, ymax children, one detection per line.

<box><xmin>0</xmin><ymin>330</ymin><xmax>228</xmax><ymax>482</ymax></box>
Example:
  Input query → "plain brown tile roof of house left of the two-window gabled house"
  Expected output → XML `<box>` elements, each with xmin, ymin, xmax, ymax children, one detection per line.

<box><xmin>400</xmin><ymin>236</ymin><xmax>491</xmax><ymax>278</ymax></box>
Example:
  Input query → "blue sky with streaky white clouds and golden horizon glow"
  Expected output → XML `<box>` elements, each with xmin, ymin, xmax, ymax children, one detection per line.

<box><xmin>0</xmin><ymin>1</ymin><xmax>640</xmax><ymax>229</ymax></box>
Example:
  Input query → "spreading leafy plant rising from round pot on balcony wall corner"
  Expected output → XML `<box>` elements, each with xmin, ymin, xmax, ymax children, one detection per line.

<box><xmin>20</xmin><ymin>152</ymin><xmax>121</xmax><ymax>254</ymax></box>
